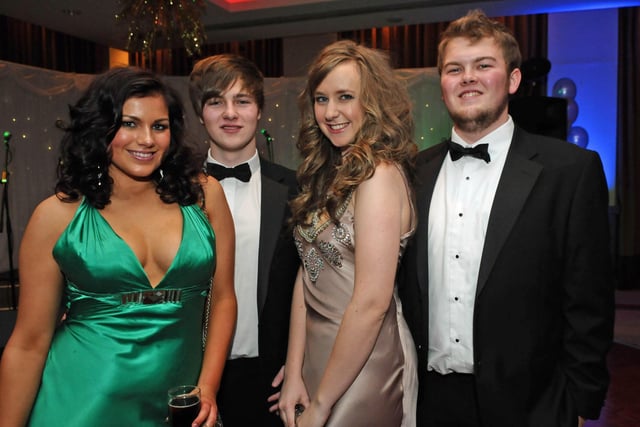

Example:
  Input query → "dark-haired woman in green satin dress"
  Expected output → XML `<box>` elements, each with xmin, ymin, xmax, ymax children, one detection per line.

<box><xmin>0</xmin><ymin>67</ymin><xmax>236</xmax><ymax>427</ymax></box>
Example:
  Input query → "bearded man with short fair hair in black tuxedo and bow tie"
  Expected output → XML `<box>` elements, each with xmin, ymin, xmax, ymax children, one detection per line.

<box><xmin>400</xmin><ymin>11</ymin><xmax>614</xmax><ymax>427</ymax></box>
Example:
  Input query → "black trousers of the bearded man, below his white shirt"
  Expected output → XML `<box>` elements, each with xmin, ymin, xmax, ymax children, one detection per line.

<box><xmin>418</xmin><ymin>371</ymin><xmax>482</xmax><ymax>427</ymax></box>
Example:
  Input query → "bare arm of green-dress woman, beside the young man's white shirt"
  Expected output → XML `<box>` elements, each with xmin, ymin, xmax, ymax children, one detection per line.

<box><xmin>196</xmin><ymin>178</ymin><xmax>237</xmax><ymax>425</ymax></box>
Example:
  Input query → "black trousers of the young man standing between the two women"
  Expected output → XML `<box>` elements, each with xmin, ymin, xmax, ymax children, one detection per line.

<box><xmin>217</xmin><ymin>358</ymin><xmax>282</xmax><ymax>427</ymax></box>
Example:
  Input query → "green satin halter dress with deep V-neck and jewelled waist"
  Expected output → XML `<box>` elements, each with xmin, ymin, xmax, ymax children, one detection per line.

<box><xmin>29</xmin><ymin>201</ymin><xmax>215</xmax><ymax>427</ymax></box>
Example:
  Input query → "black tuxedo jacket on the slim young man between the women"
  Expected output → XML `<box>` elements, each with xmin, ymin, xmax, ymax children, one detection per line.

<box><xmin>254</xmin><ymin>157</ymin><xmax>300</xmax><ymax>383</ymax></box>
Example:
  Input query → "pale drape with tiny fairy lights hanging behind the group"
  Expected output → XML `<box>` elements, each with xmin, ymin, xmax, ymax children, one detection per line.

<box><xmin>0</xmin><ymin>61</ymin><xmax>451</xmax><ymax>273</ymax></box>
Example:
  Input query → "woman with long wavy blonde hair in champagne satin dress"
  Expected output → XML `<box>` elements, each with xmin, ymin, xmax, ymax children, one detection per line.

<box><xmin>278</xmin><ymin>41</ymin><xmax>417</xmax><ymax>427</ymax></box>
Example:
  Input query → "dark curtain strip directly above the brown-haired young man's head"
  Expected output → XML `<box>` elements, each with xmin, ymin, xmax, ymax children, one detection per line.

<box><xmin>129</xmin><ymin>39</ymin><xmax>283</xmax><ymax>77</ymax></box>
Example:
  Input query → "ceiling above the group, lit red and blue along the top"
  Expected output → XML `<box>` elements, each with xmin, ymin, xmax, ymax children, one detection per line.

<box><xmin>0</xmin><ymin>0</ymin><xmax>640</xmax><ymax>49</ymax></box>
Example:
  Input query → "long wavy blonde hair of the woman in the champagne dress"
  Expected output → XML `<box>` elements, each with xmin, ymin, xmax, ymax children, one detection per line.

<box><xmin>291</xmin><ymin>40</ymin><xmax>418</xmax><ymax>225</ymax></box>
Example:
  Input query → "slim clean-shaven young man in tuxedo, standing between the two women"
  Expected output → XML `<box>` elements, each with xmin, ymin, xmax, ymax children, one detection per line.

<box><xmin>189</xmin><ymin>54</ymin><xmax>299</xmax><ymax>427</ymax></box>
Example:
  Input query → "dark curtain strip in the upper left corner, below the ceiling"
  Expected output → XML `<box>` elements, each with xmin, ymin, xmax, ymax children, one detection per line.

<box><xmin>0</xmin><ymin>15</ymin><xmax>109</xmax><ymax>74</ymax></box>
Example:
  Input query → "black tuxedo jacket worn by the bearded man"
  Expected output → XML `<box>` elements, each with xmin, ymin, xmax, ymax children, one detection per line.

<box><xmin>399</xmin><ymin>127</ymin><xmax>614</xmax><ymax>427</ymax></box>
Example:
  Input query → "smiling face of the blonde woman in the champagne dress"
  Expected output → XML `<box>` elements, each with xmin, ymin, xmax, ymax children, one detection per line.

<box><xmin>313</xmin><ymin>61</ymin><xmax>364</xmax><ymax>149</ymax></box>
